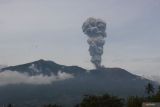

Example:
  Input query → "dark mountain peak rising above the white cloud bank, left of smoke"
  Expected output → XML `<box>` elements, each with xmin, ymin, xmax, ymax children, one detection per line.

<box><xmin>0</xmin><ymin>59</ymin><xmax>86</xmax><ymax>76</ymax></box>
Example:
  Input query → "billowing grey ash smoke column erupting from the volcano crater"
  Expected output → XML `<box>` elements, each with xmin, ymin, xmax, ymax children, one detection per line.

<box><xmin>82</xmin><ymin>18</ymin><xmax>107</xmax><ymax>68</ymax></box>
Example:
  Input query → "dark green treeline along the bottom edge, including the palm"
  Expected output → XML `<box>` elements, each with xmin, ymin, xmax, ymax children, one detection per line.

<box><xmin>3</xmin><ymin>83</ymin><xmax>160</xmax><ymax>107</ymax></box>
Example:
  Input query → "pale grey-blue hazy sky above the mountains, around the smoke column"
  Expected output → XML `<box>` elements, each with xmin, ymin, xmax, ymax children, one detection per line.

<box><xmin>0</xmin><ymin>0</ymin><xmax>160</xmax><ymax>76</ymax></box>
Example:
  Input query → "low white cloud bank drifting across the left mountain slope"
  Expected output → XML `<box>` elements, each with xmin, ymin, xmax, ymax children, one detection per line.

<box><xmin>0</xmin><ymin>71</ymin><xmax>74</xmax><ymax>86</ymax></box>
